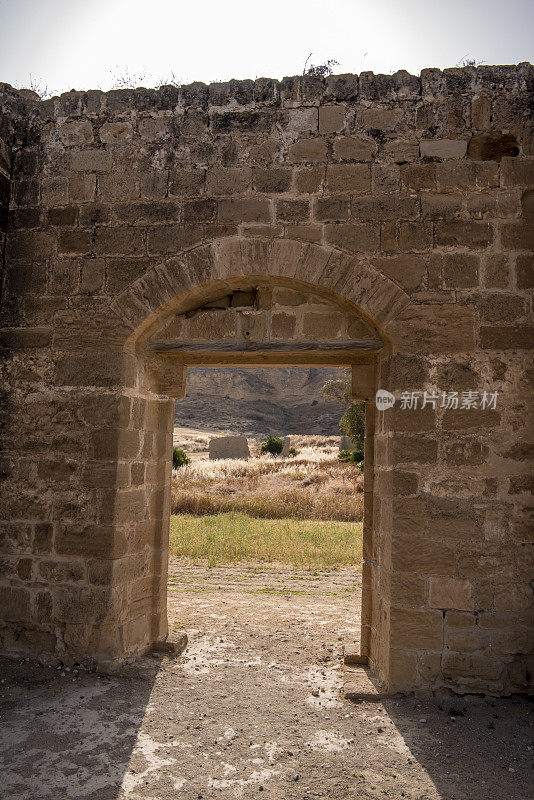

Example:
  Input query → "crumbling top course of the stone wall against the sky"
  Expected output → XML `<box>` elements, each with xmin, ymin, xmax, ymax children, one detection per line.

<box><xmin>0</xmin><ymin>62</ymin><xmax>534</xmax><ymax>118</ymax></box>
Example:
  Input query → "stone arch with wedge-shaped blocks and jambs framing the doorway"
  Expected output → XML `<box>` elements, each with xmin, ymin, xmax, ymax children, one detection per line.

<box><xmin>92</xmin><ymin>238</ymin><xmax>416</xmax><ymax>685</ymax></box>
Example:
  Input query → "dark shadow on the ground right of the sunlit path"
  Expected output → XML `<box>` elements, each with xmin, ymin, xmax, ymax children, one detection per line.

<box><xmin>381</xmin><ymin>693</ymin><xmax>534</xmax><ymax>800</ymax></box>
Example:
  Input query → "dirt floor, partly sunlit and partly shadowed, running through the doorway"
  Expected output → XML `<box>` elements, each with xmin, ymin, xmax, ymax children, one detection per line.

<box><xmin>0</xmin><ymin>563</ymin><xmax>534</xmax><ymax>800</ymax></box>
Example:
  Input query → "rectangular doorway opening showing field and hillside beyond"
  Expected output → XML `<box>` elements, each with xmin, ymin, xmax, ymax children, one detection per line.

<box><xmin>168</xmin><ymin>366</ymin><xmax>364</xmax><ymax>709</ymax></box>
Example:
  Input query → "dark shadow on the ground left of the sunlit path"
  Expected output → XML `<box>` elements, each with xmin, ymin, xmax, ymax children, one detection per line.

<box><xmin>0</xmin><ymin>659</ymin><xmax>157</xmax><ymax>800</ymax></box>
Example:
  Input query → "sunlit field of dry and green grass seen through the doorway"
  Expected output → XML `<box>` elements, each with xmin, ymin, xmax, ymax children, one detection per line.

<box><xmin>170</xmin><ymin>432</ymin><xmax>363</xmax><ymax>568</ymax></box>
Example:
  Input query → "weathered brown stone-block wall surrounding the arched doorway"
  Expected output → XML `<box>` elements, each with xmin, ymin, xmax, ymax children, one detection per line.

<box><xmin>0</xmin><ymin>64</ymin><xmax>534</xmax><ymax>692</ymax></box>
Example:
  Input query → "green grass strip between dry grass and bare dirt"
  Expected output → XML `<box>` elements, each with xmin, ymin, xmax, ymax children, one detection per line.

<box><xmin>170</xmin><ymin>512</ymin><xmax>362</xmax><ymax>569</ymax></box>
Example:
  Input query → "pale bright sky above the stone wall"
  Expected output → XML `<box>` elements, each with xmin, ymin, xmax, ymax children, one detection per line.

<box><xmin>0</xmin><ymin>0</ymin><xmax>534</xmax><ymax>93</ymax></box>
